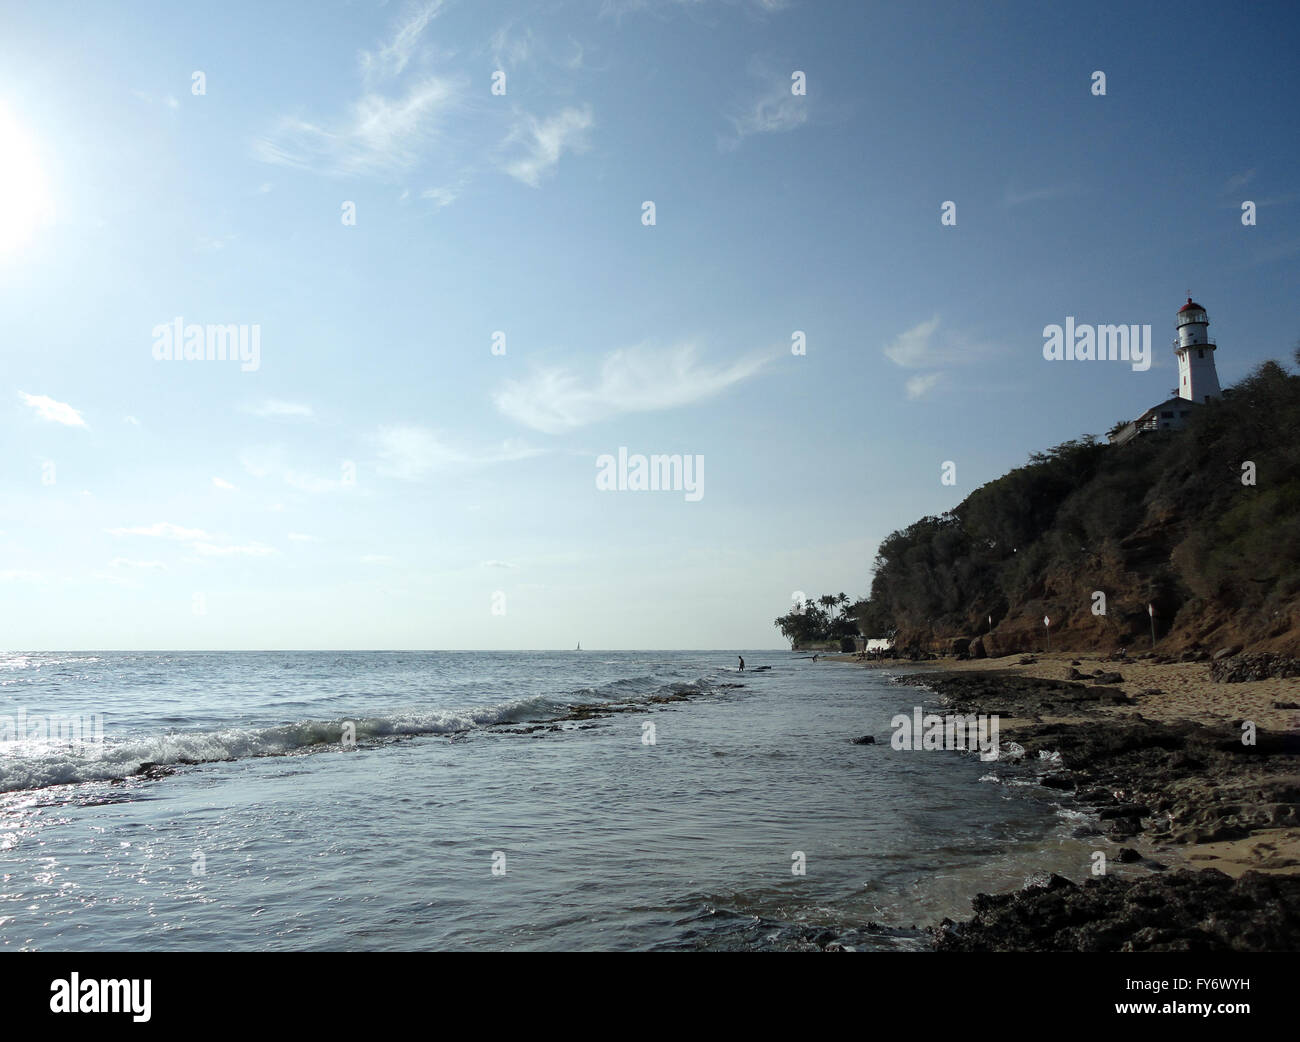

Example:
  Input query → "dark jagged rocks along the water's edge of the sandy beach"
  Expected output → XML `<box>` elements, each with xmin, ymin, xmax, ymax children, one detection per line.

<box><xmin>900</xmin><ymin>670</ymin><xmax>1300</xmax><ymax>951</ymax></box>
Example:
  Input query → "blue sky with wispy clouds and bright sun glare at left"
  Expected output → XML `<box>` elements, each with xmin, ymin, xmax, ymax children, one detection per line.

<box><xmin>0</xmin><ymin>0</ymin><xmax>1300</xmax><ymax>650</ymax></box>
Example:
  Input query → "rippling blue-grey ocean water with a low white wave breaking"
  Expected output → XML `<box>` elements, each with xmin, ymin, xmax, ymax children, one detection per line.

<box><xmin>0</xmin><ymin>651</ymin><xmax>1092</xmax><ymax>951</ymax></box>
